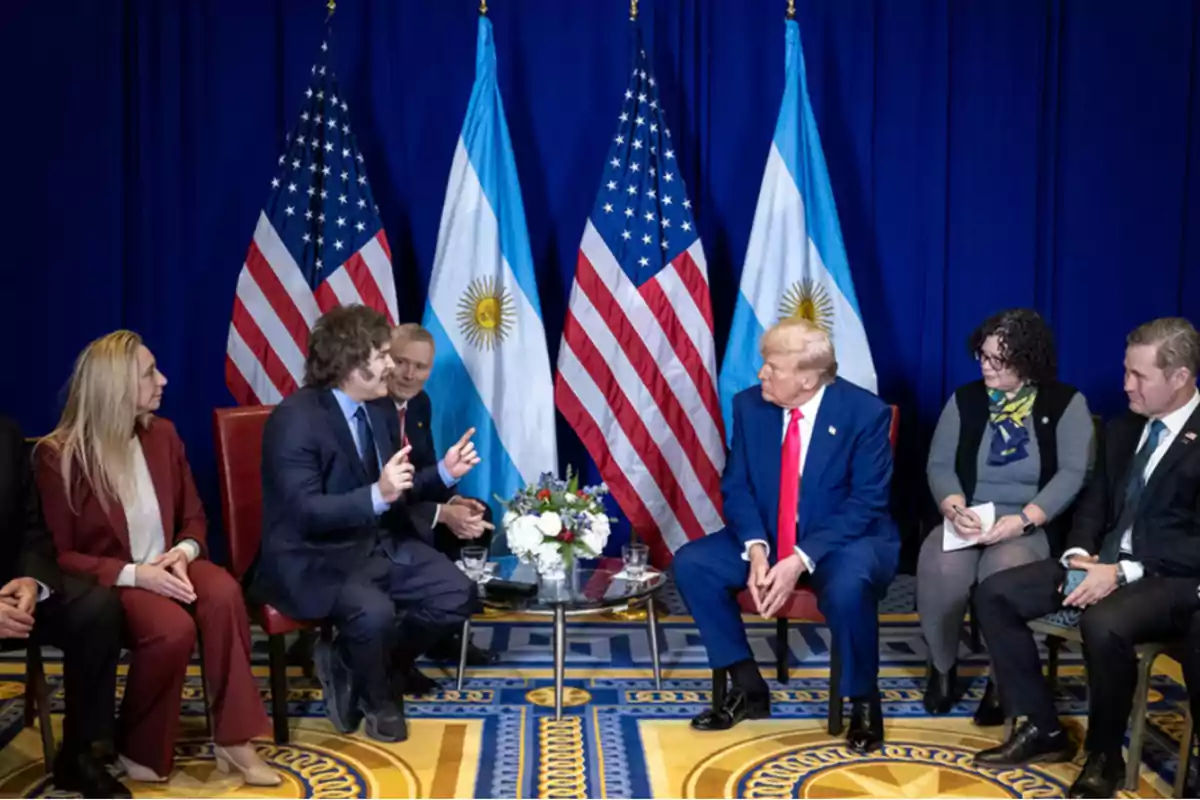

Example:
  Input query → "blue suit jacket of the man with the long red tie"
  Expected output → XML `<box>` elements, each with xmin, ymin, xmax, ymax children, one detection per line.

<box><xmin>721</xmin><ymin>378</ymin><xmax>900</xmax><ymax>569</ymax></box>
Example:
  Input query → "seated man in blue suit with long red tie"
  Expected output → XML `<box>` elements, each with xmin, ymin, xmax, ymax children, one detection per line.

<box><xmin>674</xmin><ymin>319</ymin><xmax>900</xmax><ymax>752</ymax></box>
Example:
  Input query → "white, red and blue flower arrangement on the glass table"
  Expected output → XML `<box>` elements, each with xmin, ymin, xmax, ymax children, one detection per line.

<box><xmin>497</xmin><ymin>467</ymin><xmax>610</xmax><ymax>577</ymax></box>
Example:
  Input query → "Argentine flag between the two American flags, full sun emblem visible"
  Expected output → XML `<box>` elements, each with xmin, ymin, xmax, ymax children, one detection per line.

<box><xmin>425</xmin><ymin>17</ymin><xmax>558</xmax><ymax>519</ymax></box>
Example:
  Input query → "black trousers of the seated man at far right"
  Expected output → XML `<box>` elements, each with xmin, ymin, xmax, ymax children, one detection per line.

<box><xmin>976</xmin><ymin>559</ymin><xmax>1200</xmax><ymax>753</ymax></box>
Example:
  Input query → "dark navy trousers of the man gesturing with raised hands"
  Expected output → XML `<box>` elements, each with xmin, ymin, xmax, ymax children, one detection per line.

<box><xmin>330</xmin><ymin>539</ymin><xmax>478</xmax><ymax>708</ymax></box>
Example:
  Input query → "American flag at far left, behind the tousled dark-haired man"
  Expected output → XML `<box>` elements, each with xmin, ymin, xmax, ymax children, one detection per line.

<box><xmin>226</xmin><ymin>40</ymin><xmax>398</xmax><ymax>405</ymax></box>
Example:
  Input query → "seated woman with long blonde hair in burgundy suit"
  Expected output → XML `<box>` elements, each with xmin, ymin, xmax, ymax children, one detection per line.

<box><xmin>36</xmin><ymin>331</ymin><xmax>281</xmax><ymax>786</ymax></box>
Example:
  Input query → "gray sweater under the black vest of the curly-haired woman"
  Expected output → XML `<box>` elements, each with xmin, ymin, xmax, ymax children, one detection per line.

<box><xmin>928</xmin><ymin>392</ymin><xmax>1096</xmax><ymax>522</ymax></box>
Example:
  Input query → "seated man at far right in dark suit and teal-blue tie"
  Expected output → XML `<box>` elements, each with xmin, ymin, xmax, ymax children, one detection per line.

<box><xmin>974</xmin><ymin>318</ymin><xmax>1200</xmax><ymax>798</ymax></box>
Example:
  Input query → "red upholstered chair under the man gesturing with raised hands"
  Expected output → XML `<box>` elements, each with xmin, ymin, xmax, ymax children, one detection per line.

<box><xmin>212</xmin><ymin>405</ymin><xmax>329</xmax><ymax>745</ymax></box>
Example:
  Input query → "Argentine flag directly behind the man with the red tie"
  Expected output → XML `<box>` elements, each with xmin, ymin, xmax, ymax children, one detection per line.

<box><xmin>719</xmin><ymin>19</ymin><xmax>876</xmax><ymax>432</ymax></box>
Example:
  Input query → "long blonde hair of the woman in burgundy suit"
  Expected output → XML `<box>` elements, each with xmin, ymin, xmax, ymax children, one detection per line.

<box><xmin>38</xmin><ymin>331</ymin><xmax>149</xmax><ymax>511</ymax></box>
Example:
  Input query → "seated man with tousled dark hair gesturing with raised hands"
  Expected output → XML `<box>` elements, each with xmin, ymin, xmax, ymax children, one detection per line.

<box><xmin>257</xmin><ymin>306</ymin><xmax>478</xmax><ymax>741</ymax></box>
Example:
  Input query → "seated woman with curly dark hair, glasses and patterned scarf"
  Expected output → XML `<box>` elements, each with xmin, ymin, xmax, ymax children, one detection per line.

<box><xmin>917</xmin><ymin>308</ymin><xmax>1094</xmax><ymax>726</ymax></box>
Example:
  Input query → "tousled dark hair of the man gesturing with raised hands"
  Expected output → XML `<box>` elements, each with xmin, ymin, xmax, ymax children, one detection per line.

<box><xmin>304</xmin><ymin>306</ymin><xmax>391</xmax><ymax>389</ymax></box>
